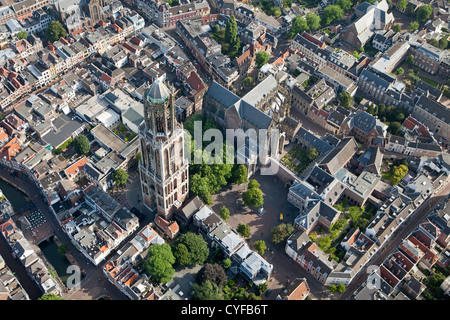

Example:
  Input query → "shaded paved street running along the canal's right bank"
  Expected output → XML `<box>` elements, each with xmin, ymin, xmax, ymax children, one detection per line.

<box><xmin>0</xmin><ymin>167</ymin><xmax>126</xmax><ymax>300</ymax></box>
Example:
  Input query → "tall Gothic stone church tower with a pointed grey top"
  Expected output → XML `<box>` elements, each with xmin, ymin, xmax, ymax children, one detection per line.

<box><xmin>139</xmin><ymin>80</ymin><xmax>189</xmax><ymax>219</ymax></box>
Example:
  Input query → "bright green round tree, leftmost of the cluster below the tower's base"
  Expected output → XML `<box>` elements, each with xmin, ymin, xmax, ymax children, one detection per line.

<box><xmin>144</xmin><ymin>243</ymin><xmax>175</xmax><ymax>283</ymax></box>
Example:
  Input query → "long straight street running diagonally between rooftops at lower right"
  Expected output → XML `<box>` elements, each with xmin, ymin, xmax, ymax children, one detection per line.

<box><xmin>339</xmin><ymin>184</ymin><xmax>450</xmax><ymax>300</ymax></box>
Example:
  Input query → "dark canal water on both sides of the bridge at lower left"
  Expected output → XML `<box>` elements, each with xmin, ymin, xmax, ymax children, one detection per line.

<box><xmin>0</xmin><ymin>179</ymin><xmax>70</xmax><ymax>284</ymax></box>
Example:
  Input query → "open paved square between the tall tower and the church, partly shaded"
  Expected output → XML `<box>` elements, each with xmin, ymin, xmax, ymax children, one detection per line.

<box><xmin>212</xmin><ymin>172</ymin><xmax>329</xmax><ymax>300</ymax></box>
